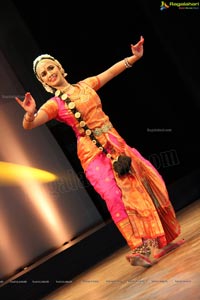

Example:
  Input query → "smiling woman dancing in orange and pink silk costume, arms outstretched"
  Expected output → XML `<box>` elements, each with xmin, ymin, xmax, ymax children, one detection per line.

<box><xmin>16</xmin><ymin>36</ymin><xmax>183</xmax><ymax>267</ymax></box>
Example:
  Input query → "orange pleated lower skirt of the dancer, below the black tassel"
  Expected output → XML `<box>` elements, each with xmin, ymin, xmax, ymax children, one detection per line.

<box><xmin>116</xmin><ymin>159</ymin><xmax>180</xmax><ymax>248</ymax></box>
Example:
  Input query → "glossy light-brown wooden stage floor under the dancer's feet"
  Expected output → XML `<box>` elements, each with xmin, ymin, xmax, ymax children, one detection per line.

<box><xmin>42</xmin><ymin>200</ymin><xmax>200</xmax><ymax>300</ymax></box>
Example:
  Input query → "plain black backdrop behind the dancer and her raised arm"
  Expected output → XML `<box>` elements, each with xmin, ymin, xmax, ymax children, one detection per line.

<box><xmin>7</xmin><ymin>0</ymin><xmax>200</xmax><ymax>218</ymax></box>
